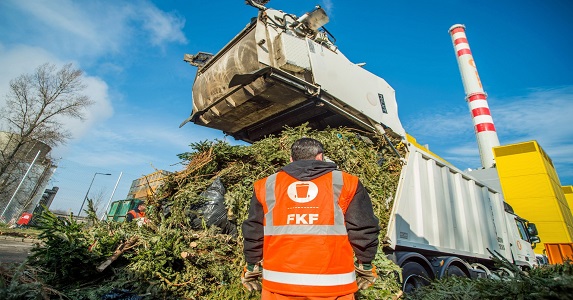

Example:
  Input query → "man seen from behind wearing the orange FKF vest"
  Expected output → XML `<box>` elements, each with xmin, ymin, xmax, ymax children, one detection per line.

<box><xmin>241</xmin><ymin>138</ymin><xmax>380</xmax><ymax>300</ymax></box>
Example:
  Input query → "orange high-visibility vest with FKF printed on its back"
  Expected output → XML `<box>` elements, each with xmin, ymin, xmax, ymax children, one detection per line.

<box><xmin>254</xmin><ymin>171</ymin><xmax>358</xmax><ymax>296</ymax></box>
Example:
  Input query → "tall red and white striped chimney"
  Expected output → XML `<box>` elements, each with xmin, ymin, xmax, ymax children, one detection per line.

<box><xmin>449</xmin><ymin>24</ymin><xmax>499</xmax><ymax>169</ymax></box>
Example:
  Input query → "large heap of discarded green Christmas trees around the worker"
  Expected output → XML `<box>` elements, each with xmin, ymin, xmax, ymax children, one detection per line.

<box><xmin>1</xmin><ymin>125</ymin><xmax>401</xmax><ymax>299</ymax></box>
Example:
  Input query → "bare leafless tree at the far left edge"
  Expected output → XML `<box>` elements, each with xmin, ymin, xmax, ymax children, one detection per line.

<box><xmin>0</xmin><ymin>63</ymin><xmax>94</xmax><ymax>206</ymax></box>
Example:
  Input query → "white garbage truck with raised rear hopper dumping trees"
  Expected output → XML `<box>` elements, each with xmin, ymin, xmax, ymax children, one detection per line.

<box><xmin>181</xmin><ymin>1</ymin><xmax>539</xmax><ymax>291</ymax></box>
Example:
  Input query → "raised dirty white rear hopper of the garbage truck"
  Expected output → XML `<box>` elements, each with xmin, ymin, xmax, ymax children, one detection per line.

<box><xmin>181</xmin><ymin>0</ymin><xmax>405</xmax><ymax>142</ymax></box>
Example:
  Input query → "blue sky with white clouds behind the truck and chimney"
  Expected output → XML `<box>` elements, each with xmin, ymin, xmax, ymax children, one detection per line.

<box><xmin>0</xmin><ymin>0</ymin><xmax>573</xmax><ymax>213</ymax></box>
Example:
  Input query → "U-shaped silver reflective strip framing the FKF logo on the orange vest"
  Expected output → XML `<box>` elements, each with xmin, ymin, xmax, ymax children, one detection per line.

<box><xmin>265</xmin><ymin>171</ymin><xmax>348</xmax><ymax>235</ymax></box>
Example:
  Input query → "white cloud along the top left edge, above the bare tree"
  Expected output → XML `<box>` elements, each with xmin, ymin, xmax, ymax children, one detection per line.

<box><xmin>5</xmin><ymin>0</ymin><xmax>187</xmax><ymax>58</ymax></box>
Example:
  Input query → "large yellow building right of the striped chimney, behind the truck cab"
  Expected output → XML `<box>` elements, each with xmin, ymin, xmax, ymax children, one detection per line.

<box><xmin>493</xmin><ymin>141</ymin><xmax>573</xmax><ymax>254</ymax></box>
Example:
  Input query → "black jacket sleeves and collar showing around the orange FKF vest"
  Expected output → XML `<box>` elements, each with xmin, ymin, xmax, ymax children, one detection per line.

<box><xmin>239</xmin><ymin>160</ymin><xmax>380</xmax><ymax>264</ymax></box>
